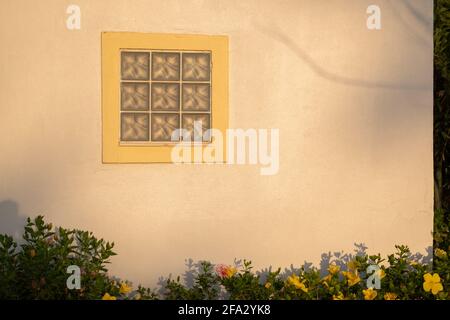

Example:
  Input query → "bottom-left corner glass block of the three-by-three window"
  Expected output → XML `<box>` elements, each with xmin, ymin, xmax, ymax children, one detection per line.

<box><xmin>120</xmin><ymin>113</ymin><xmax>149</xmax><ymax>141</ymax></box>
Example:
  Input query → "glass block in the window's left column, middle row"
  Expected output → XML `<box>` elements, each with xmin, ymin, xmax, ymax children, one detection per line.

<box><xmin>120</xmin><ymin>82</ymin><xmax>149</xmax><ymax>111</ymax></box>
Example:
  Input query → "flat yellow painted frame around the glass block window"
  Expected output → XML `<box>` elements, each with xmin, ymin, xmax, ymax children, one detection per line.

<box><xmin>101</xmin><ymin>32</ymin><xmax>228</xmax><ymax>163</ymax></box>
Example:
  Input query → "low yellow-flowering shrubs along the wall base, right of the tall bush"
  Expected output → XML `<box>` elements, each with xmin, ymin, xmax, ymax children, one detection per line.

<box><xmin>162</xmin><ymin>246</ymin><xmax>450</xmax><ymax>300</ymax></box>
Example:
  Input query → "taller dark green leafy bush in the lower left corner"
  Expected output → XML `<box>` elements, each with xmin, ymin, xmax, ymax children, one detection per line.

<box><xmin>0</xmin><ymin>216</ymin><xmax>115</xmax><ymax>299</ymax></box>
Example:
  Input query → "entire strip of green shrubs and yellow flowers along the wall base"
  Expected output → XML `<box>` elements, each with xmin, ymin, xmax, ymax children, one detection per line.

<box><xmin>0</xmin><ymin>216</ymin><xmax>450</xmax><ymax>300</ymax></box>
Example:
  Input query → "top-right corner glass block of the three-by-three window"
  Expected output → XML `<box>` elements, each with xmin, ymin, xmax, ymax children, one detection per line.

<box><xmin>183</xmin><ymin>53</ymin><xmax>211</xmax><ymax>81</ymax></box>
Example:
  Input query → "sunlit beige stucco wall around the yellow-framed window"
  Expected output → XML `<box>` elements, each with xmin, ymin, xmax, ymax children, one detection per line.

<box><xmin>0</xmin><ymin>0</ymin><xmax>433</xmax><ymax>285</ymax></box>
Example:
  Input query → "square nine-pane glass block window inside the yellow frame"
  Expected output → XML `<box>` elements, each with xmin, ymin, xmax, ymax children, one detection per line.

<box><xmin>119</xmin><ymin>49</ymin><xmax>211</xmax><ymax>144</ymax></box>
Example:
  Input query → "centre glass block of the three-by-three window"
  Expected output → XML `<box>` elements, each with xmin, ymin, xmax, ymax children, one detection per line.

<box><xmin>152</xmin><ymin>82</ymin><xmax>180</xmax><ymax>111</ymax></box>
